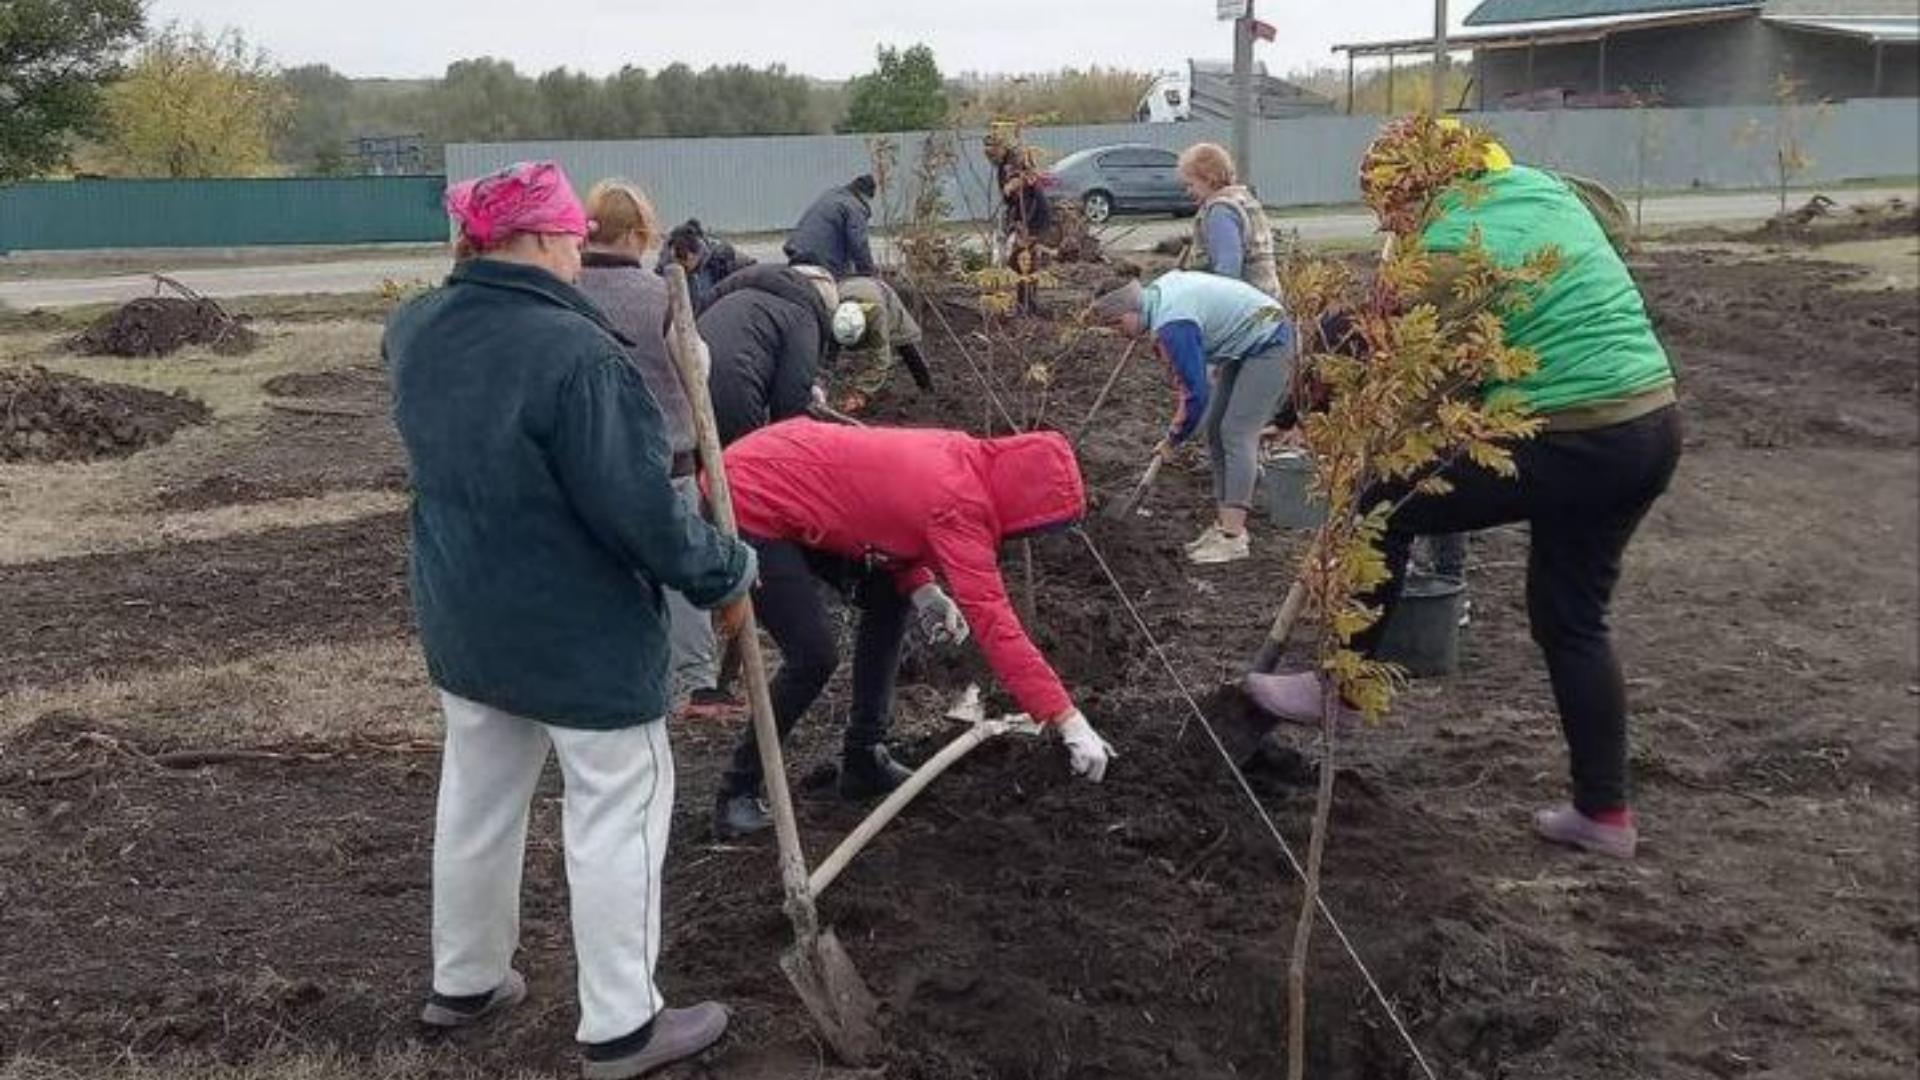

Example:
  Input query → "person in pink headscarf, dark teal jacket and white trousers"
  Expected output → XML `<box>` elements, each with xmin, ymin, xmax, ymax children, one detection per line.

<box><xmin>382</xmin><ymin>163</ymin><xmax>756</xmax><ymax>1080</ymax></box>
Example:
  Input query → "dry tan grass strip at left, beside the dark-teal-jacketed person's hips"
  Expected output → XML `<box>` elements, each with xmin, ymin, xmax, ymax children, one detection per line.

<box><xmin>0</xmin><ymin>638</ymin><xmax>440</xmax><ymax>748</ymax></box>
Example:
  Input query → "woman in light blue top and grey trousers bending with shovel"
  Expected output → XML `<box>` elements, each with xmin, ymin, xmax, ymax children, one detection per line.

<box><xmin>1094</xmin><ymin>271</ymin><xmax>1294</xmax><ymax>565</ymax></box>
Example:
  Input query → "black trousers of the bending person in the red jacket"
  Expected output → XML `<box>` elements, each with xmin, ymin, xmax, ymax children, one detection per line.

<box><xmin>726</xmin><ymin>536</ymin><xmax>912</xmax><ymax>794</ymax></box>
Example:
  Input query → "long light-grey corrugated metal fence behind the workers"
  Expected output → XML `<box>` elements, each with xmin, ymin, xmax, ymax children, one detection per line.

<box><xmin>447</xmin><ymin>100</ymin><xmax>1920</xmax><ymax>233</ymax></box>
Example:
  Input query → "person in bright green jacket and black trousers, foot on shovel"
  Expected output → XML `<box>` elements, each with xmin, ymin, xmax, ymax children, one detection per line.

<box><xmin>1246</xmin><ymin>117</ymin><xmax>1680</xmax><ymax>859</ymax></box>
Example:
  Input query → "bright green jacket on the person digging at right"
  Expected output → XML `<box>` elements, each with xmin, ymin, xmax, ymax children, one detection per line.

<box><xmin>1421</xmin><ymin>165</ymin><xmax>1674</xmax><ymax>415</ymax></box>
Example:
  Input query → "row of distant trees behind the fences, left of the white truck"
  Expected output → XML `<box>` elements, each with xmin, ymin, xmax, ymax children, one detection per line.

<box><xmin>0</xmin><ymin>0</ymin><xmax>1148</xmax><ymax>183</ymax></box>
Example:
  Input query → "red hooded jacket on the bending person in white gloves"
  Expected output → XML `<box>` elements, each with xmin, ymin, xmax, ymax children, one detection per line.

<box><xmin>726</xmin><ymin>419</ymin><xmax>1087</xmax><ymax>721</ymax></box>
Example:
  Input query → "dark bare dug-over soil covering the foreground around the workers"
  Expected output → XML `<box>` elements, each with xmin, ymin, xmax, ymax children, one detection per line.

<box><xmin>0</xmin><ymin>247</ymin><xmax>1920</xmax><ymax>1080</ymax></box>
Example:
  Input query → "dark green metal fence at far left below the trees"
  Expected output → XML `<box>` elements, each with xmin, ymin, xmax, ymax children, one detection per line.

<box><xmin>0</xmin><ymin>177</ymin><xmax>447</xmax><ymax>252</ymax></box>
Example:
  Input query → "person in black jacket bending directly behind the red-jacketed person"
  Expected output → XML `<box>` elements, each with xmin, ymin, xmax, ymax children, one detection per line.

<box><xmin>699</xmin><ymin>263</ymin><xmax>839</xmax><ymax>444</ymax></box>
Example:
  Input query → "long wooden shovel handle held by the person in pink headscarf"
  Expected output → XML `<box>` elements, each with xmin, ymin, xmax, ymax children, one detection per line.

<box><xmin>666</xmin><ymin>265</ymin><xmax>818</xmax><ymax>936</ymax></box>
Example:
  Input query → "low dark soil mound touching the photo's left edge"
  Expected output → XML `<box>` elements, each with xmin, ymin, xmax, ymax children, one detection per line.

<box><xmin>0</xmin><ymin>367</ymin><xmax>211</xmax><ymax>461</ymax></box>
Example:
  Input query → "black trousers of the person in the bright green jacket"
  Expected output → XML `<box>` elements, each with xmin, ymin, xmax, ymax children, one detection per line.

<box><xmin>1354</xmin><ymin>405</ymin><xmax>1680</xmax><ymax>813</ymax></box>
